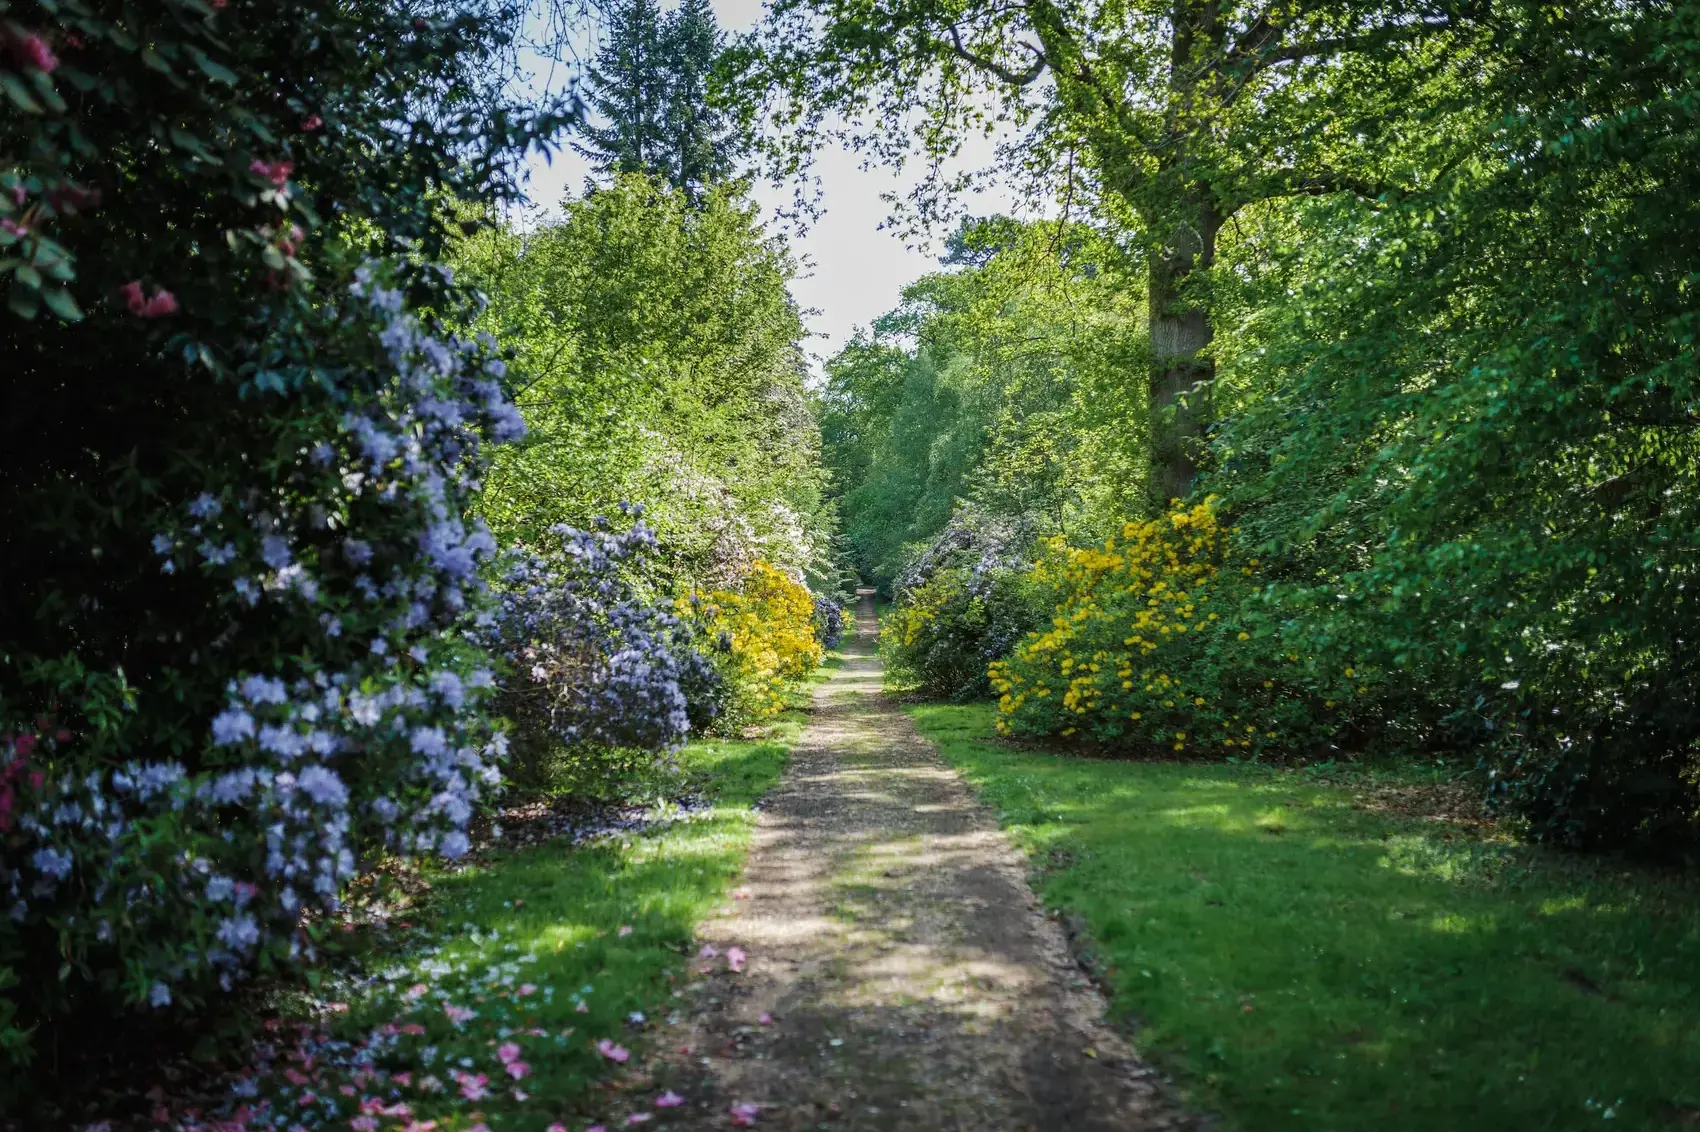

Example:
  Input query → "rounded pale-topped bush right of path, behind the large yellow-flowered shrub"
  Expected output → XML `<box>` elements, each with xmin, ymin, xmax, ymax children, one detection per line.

<box><xmin>879</xmin><ymin>512</ymin><xmax>1042</xmax><ymax>700</ymax></box>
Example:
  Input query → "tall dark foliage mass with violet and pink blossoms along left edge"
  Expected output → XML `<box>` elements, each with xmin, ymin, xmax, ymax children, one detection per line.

<box><xmin>0</xmin><ymin>0</ymin><xmax>558</xmax><ymax>1074</ymax></box>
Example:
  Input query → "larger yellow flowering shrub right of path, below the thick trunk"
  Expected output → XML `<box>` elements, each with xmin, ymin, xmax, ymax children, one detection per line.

<box><xmin>989</xmin><ymin>498</ymin><xmax>1370</xmax><ymax>747</ymax></box>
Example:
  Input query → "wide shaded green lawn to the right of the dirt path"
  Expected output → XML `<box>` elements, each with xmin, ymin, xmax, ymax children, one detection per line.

<box><xmin>913</xmin><ymin>705</ymin><xmax>1700</xmax><ymax>1132</ymax></box>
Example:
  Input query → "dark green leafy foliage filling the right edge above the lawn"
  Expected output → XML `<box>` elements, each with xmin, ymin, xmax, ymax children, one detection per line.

<box><xmin>1217</xmin><ymin>3</ymin><xmax>1700</xmax><ymax>848</ymax></box>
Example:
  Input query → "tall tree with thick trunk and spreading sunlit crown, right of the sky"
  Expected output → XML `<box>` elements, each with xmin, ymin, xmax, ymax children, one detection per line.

<box><xmin>748</xmin><ymin>0</ymin><xmax>1488</xmax><ymax>503</ymax></box>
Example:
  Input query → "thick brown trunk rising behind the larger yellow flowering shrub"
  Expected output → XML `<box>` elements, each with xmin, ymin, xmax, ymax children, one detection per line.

<box><xmin>1148</xmin><ymin>206</ymin><xmax>1221</xmax><ymax>508</ymax></box>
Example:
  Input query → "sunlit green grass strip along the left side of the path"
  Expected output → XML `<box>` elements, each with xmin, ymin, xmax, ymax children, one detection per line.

<box><xmin>255</xmin><ymin>712</ymin><xmax>802</xmax><ymax>1132</ymax></box>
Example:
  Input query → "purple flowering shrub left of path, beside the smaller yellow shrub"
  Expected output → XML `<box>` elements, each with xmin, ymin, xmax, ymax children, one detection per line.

<box><xmin>493</xmin><ymin>508</ymin><xmax>719</xmax><ymax>785</ymax></box>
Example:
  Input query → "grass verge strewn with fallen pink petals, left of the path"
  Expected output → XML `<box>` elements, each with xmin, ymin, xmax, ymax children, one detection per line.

<box><xmin>118</xmin><ymin>712</ymin><xmax>801</xmax><ymax>1132</ymax></box>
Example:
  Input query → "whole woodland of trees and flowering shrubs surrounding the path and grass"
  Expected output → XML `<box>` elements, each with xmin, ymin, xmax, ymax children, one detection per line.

<box><xmin>0</xmin><ymin>0</ymin><xmax>1700</xmax><ymax>1130</ymax></box>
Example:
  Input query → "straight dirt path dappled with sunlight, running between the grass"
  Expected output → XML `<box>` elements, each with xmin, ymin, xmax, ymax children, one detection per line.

<box><xmin>655</xmin><ymin>597</ymin><xmax>1183</xmax><ymax>1132</ymax></box>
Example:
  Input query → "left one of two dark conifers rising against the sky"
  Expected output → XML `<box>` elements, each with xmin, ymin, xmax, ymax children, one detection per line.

<box><xmin>573</xmin><ymin>0</ymin><xmax>669</xmax><ymax>175</ymax></box>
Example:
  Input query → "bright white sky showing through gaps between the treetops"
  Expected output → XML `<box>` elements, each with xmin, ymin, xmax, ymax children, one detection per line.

<box><xmin>513</xmin><ymin>0</ymin><xmax>1010</xmax><ymax>369</ymax></box>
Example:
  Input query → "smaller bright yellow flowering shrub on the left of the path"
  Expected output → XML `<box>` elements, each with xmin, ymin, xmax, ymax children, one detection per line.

<box><xmin>678</xmin><ymin>561</ymin><xmax>823</xmax><ymax>726</ymax></box>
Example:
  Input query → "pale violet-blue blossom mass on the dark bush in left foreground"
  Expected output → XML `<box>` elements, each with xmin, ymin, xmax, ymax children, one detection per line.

<box><xmin>0</xmin><ymin>261</ymin><xmax>523</xmax><ymax>1006</ymax></box>
